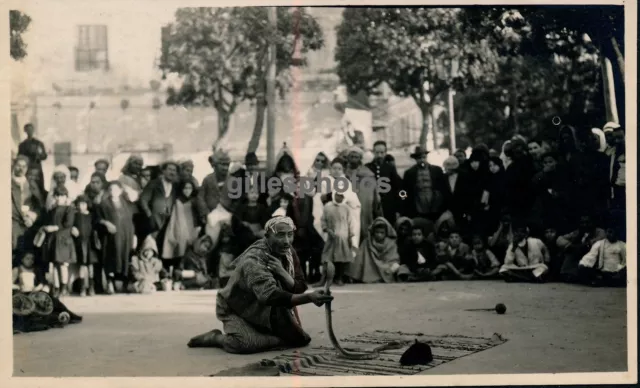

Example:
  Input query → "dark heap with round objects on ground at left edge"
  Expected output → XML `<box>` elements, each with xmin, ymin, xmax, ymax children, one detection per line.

<box><xmin>13</xmin><ymin>291</ymin><xmax>82</xmax><ymax>334</ymax></box>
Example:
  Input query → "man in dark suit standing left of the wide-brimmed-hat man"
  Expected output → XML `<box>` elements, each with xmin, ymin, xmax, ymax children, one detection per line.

<box><xmin>365</xmin><ymin>140</ymin><xmax>402</xmax><ymax>225</ymax></box>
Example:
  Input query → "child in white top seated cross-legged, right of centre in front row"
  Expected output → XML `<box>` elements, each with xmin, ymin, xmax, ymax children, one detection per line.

<box><xmin>499</xmin><ymin>226</ymin><xmax>549</xmax><ymax>282</ymax></box>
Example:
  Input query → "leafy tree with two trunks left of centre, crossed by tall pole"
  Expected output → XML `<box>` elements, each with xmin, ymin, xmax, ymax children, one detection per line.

<box><xmin>160</xmin><ymin>7</ymin><xmax>323</xmax><ymax>149</ymax></box>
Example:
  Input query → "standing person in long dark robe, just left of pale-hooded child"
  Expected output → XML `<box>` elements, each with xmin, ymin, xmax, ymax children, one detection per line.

<box><xmin>96</xmin><ymin>181</ymin><xmax>137</xmax><ymax>294</ymax></box>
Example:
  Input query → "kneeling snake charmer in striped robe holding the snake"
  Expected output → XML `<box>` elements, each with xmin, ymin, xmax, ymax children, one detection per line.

<box><xmin>189</xmin><ymin>217</ymin><xmax>333</xmax><ymax>354</ymax></box>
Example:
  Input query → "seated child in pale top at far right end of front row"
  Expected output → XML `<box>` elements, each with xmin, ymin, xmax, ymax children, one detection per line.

<box><xmin>580</xmin><ymin>227</ymin><xmax>627</xmax><ymax>287</ymax></box>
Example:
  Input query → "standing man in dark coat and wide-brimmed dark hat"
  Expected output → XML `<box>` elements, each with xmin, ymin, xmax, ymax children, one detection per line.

<box><xmin>403</xmin><ymin>146</ymin><xmax>444</xmax><ymax>221</ymax></box>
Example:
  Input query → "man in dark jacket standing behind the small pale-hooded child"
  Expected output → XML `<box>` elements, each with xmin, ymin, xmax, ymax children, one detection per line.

<box><xmin>139</xmin><ymin>161</ymin><xmax>178</xmax><ymax>255</ymax></box>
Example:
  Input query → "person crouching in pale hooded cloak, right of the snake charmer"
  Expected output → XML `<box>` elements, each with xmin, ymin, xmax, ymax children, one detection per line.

<box><xmin>346</xmin><ymin>217</ymin><xmax>400</xmax><ymax>283</ymax></box>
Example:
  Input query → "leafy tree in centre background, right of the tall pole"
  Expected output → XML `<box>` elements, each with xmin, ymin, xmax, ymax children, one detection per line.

<box><xmin>335</xmin><ymin>7</ymin><xmax>497</xmax><ymax>150</ymax></box>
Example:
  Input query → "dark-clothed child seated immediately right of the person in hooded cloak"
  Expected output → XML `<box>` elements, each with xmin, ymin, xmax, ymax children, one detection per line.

<box><xmin>398</xmin><ymin>225</ymin><xmax>437</xmax><ymax>282</ymax></box>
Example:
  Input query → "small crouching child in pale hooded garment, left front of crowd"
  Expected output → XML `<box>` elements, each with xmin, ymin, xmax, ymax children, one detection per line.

<box><xmin>129</xmin><ymin>236</ymin><xmax>166</xmax><ymax>294</ymax></box>
